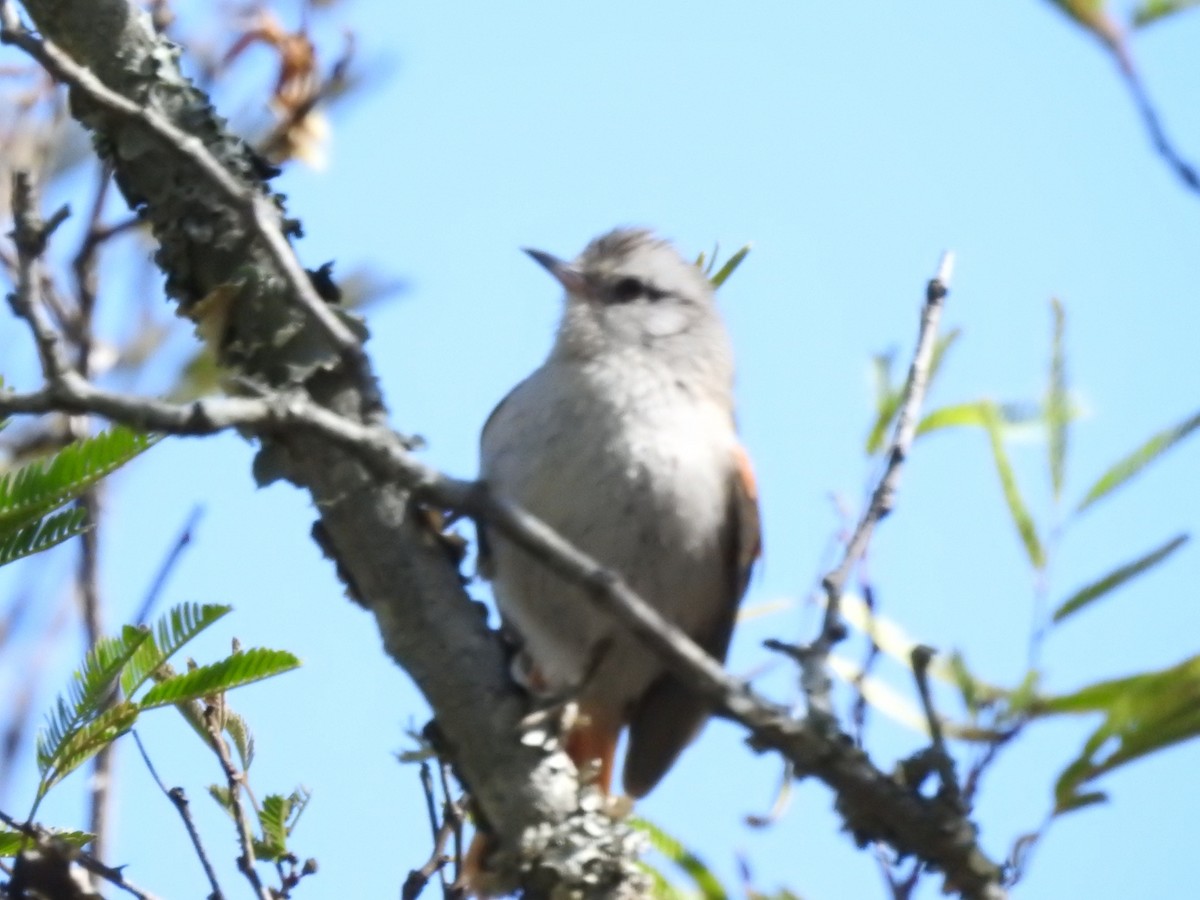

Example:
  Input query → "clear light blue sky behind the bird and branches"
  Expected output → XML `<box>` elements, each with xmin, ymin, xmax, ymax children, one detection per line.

<box><xmin>0</xmin><ymin>0</ymin><xmax>1200</xmax><ymax>900</ymax></box>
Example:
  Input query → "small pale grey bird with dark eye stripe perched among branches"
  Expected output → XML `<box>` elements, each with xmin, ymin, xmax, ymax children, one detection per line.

<box><xmin>479</xmin><ymin>228</ymin><xmax>761</xmax><ymax>799</ymax></box>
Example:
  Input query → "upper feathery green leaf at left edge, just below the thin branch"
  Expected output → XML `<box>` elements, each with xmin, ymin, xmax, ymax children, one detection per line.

<box><xmin>0</xmin><ymin>426</ymin><xmax>158</xmax><ymax>533</ymax></box>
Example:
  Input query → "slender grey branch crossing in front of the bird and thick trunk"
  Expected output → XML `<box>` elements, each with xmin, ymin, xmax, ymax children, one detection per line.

<box><xmin>0</xmin><ymin>259</ymin><xmax>1003</xmax><ymax>898</ymax></box>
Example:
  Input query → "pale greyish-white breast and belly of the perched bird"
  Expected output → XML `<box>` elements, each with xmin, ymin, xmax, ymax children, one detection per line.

<box><xmin>482</xmin><ymin>354</ymin><xmax>736</xmax><ymax>708</ymax></box>
